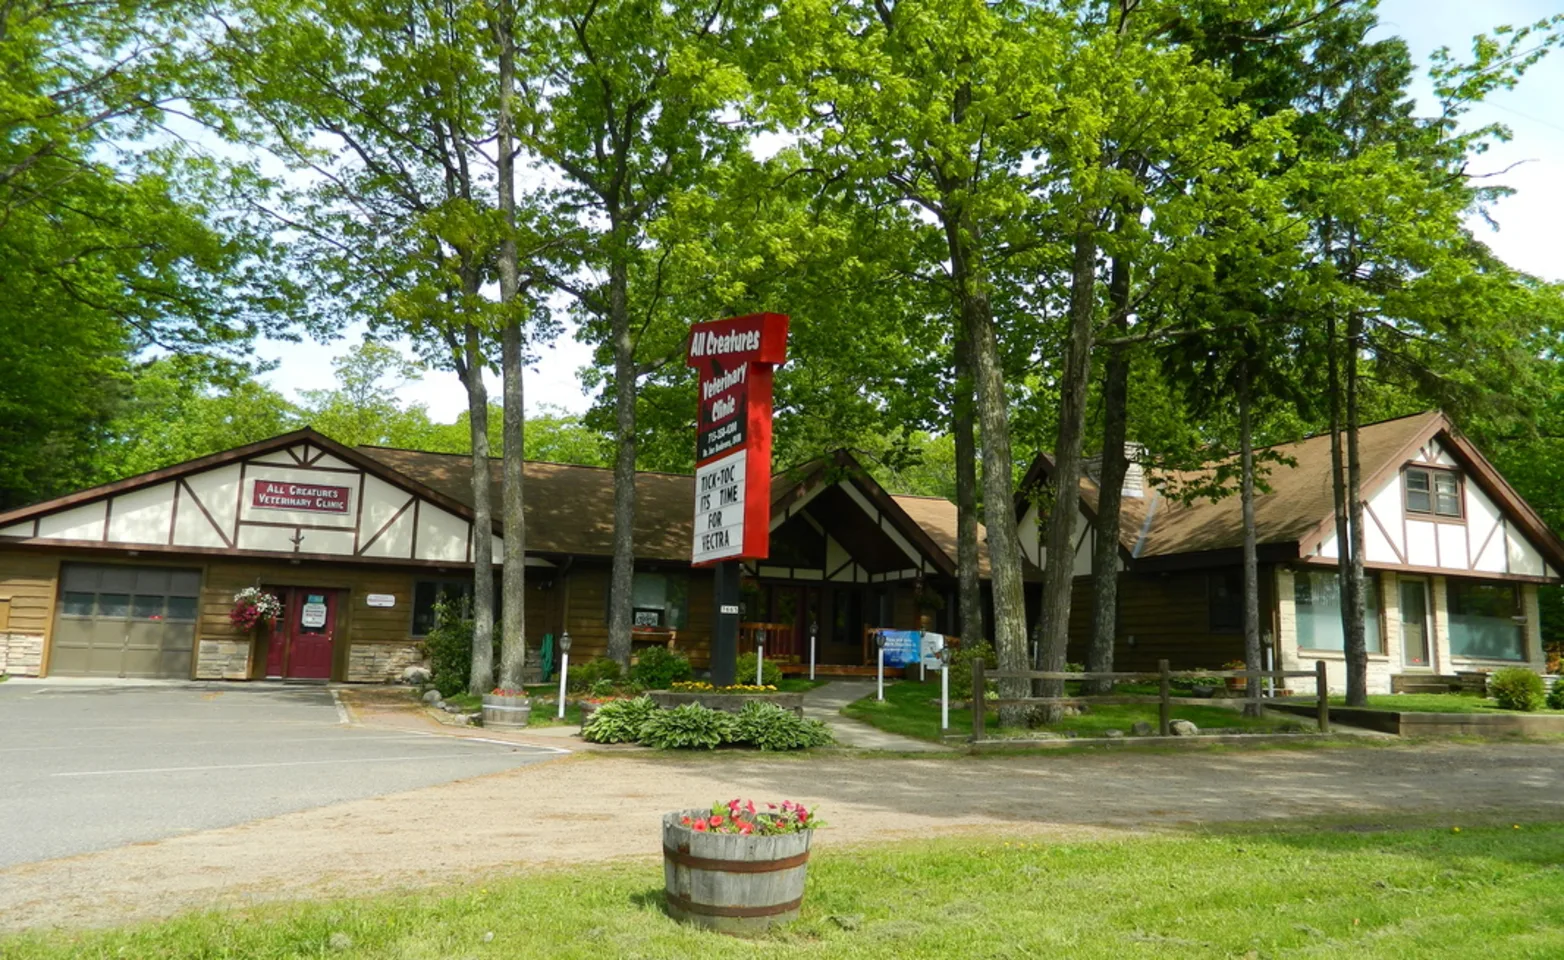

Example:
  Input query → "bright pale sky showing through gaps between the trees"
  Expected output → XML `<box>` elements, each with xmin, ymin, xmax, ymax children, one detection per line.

<box><xmin>256</xmin><ymin>0</ymin><xmax>1564</xmax><ymax>422</ymax></box>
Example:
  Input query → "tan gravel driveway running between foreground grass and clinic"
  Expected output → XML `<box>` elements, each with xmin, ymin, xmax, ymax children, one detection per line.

<box><xmin>0</xmin><ymin>743</ymin><xmax>1564</xmax><ymax>929</ymax></box>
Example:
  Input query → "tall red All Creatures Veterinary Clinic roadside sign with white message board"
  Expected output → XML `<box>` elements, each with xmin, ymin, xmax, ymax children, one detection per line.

<box><xmin>685</xmin><ymin>313</ymin><xmax>788</xmax><ymax>566</ymax></box>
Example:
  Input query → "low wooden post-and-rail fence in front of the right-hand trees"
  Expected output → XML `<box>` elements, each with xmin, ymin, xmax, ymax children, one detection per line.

<box><xmin>971</xmin><ymin>658</ymin><xmax>1331</xmax><ymax>743</ymax></box>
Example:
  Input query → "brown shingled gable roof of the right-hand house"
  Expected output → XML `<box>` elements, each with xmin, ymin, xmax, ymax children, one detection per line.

<box><xmin>1017</xmin><ymin>411</ymin><xmax>1564</xmax><ymax>569</ymax></box>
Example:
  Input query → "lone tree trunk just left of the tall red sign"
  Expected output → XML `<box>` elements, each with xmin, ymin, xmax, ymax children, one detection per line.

<box><xmin>608</xmin><ymin>243</ymin><xmax>635</xmax><ymax>669</ymax></box>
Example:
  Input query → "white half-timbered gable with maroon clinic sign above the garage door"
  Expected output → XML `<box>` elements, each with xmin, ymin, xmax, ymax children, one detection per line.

<box><xmin>0</xmin><ymin>428</ymin><xmax>500</xmax><ymax>564</ymax></box>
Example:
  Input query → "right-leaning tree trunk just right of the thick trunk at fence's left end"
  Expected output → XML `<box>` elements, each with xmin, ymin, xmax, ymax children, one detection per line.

<box><xmin>1037</xmin><ymin>220</ymin><xmax>1101</xmax><ymax>721</ymax></box>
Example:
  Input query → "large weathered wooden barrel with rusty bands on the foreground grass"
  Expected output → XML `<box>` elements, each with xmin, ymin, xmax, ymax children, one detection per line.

<box><xmin>663</xmin><ymin>810</ymin><xmax>815</xmax><ymax>935</ymax></box>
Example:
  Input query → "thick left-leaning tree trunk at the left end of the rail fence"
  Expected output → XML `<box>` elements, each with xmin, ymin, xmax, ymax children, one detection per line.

<box><xmin>945</xmin><ymin>216</ymin><xmax>1028</xmax><ymax>725</ymax></box>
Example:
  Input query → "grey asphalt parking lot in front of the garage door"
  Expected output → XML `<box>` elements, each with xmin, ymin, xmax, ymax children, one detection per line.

<box><xmin>0</xmin><ymin>682</ymin><xmax>555</xmax><ymax>868</ymax></box>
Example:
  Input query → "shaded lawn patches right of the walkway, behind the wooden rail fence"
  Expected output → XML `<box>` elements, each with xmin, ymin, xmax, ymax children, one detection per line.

<box><xmin>841</xmin><ymin>680</ymin><xmax>1300</xmax><ymax>740</ymax></box>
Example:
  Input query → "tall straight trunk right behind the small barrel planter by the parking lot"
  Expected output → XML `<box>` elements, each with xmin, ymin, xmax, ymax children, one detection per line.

<box><xmin>494</xmin><ymin>2</ymin><xmax>527</xmax><ymax>690</ymax></box>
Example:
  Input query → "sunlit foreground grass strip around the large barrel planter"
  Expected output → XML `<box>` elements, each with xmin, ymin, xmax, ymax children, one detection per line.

<box><xmin>12</xmin><ymin>811</ymin><xmax>1564</xmax><ymax>960</ymax></box>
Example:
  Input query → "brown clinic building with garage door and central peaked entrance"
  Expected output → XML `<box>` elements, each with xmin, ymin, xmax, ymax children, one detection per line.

<box><xmin>0</xmin><ymin>430</ymin><xmax>987</xmax><ymax>682</ymax></box>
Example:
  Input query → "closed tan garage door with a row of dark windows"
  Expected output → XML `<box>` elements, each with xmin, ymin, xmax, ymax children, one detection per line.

<box><xmin>48</xmin><ymin>563</ymin><xmax>200</xmax><ymax>679</ymax></box>
